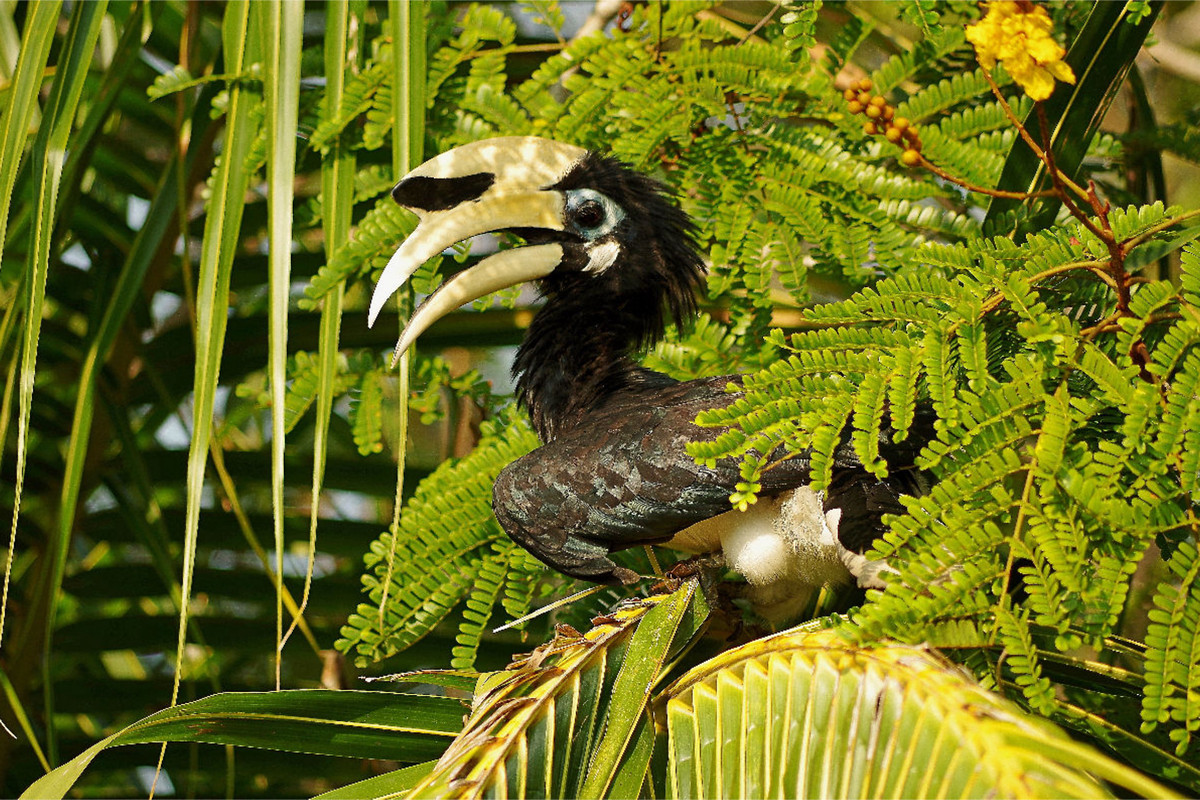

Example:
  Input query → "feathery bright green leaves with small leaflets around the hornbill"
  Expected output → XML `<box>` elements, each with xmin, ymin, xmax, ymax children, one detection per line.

<box><xmin>340</xmin><ymin>4</ymin><xmax>1200</xmax><ymax>786</ymax></box>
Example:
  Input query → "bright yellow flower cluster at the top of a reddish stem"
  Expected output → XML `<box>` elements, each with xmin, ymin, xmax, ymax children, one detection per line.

<box><xmin>967</xmin><ymin>0</ymin><xmax>1075</xmax><ymax>100</ymax></box>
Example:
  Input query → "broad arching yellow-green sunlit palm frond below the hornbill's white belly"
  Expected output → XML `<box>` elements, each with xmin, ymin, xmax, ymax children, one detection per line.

<box><xmin>659</xmin><ymin>628</ymin><xmax>1172</xmax><ymax>798</ymax></box>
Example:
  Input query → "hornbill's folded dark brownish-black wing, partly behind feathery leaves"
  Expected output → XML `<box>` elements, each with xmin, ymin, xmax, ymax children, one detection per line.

<box><xmin>493</xmin><ymin>377</ymin><xmax>809</xmax><ymax>581</ymax></box>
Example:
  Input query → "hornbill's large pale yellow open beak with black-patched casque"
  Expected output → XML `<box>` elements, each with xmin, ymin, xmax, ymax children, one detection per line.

<box><xmin>367</xmin><ymin>137</ymin><xmax>586</xmax><ymax>361</ymax></box>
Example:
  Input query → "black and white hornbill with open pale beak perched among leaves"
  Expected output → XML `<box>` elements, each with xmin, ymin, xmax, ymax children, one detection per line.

<box><xmin>368</xmin><ymin>137</ymin><xmax>922</xmax><ymax>603</ymax></box>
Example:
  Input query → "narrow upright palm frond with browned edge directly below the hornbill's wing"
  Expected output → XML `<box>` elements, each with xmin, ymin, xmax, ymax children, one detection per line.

<box><xmin>407</xmin><ymin>582</ymin><xmax>708</xmax><ymax>798</ymax></box>
